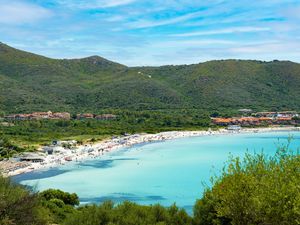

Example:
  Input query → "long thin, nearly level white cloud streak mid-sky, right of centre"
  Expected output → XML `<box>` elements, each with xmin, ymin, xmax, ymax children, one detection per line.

<box><xmin>172</xmin><ymin>27</ymin><xmax>271</xmax><ymax>37</ymax></box>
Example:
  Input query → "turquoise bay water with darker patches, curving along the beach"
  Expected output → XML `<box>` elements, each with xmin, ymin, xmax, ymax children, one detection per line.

<box><xmin>14</xmin><ymin>132</ymin><xmax>300</xmax><ymax>211</ymax></box>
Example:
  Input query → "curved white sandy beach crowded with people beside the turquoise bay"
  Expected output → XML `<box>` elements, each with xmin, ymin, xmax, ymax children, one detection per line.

<box><xmin>0</xmin><ymin>127</ymin><xmax>300</xmax><ymax>177</ymax></box>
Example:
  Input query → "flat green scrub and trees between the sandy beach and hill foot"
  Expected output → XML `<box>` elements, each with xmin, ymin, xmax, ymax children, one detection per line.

<box><xmin>0</xmin><ymin>110</ymin><xmax>210</xmax><ymax>155</ymax></box>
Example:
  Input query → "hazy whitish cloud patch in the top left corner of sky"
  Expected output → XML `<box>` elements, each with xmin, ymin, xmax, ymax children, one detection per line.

<box><xmin>0</xmin><ymin>1</ymin><xmax>52</xmax><ymax>24</ymax></box>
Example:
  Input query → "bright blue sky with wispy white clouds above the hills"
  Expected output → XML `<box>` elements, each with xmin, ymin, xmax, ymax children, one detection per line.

<box><xmin>0</xmin><ymin>0</ymin><xmax>300</xmax><ymax>66</ymax></box>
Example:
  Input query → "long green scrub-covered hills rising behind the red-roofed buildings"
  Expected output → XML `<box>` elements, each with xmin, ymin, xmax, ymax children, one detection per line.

<box><xmin>0</xmin><ymin>43</ymin><xmax>300</xmax><ymax>113</ymax></box>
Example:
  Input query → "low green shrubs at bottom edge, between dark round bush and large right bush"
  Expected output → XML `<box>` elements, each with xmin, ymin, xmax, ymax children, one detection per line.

<box><xmin>64</xmin><ymin>202</ymin><xmax>192</xmax><ymax>225</ymax></box>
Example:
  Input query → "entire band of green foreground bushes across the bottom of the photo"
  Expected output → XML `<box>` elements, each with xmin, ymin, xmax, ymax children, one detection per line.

<box><xmin>0</xmin><ymin>147</ymin><xmax>300</xmax><ymax>225</ymax></box>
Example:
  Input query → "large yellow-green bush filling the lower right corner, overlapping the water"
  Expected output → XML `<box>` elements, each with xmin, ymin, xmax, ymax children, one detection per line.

<box><xmin>194</xmin><ymin>145</ymin><xmax>300</xmax><ymax>225</ymax></box>
